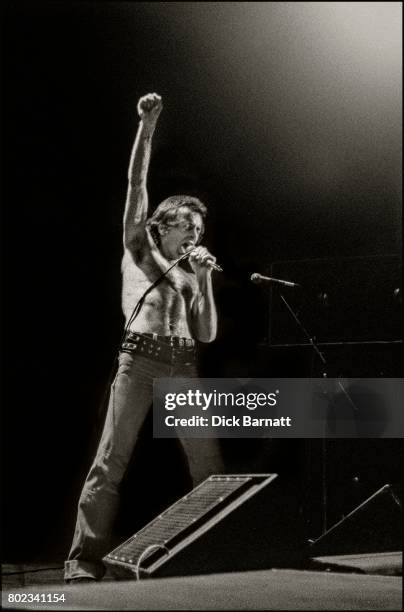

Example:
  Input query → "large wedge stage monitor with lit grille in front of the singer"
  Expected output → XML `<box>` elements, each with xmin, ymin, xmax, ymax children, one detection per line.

<box><xmin>103</xmin><ymin>474</ymin><xmax>303</xmax><ymax>579</ymax></box>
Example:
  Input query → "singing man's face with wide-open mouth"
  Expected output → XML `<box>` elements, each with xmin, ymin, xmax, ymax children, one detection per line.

<box><xmin>160</xmin><ymin>206</ymin><xmax>203</xmax><ymax>259</ymax></box>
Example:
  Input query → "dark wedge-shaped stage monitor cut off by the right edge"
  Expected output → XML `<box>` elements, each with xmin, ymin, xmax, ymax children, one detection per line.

<box><xmin>310</xmin><ymin>484</ymin><xmax>403</xmax><ymax>557</ymax></box>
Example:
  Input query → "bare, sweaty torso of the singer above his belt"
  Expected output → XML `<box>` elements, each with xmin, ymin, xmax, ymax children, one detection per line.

<box><xmin>122</xmin><ymin>246</ymin><xmax>198</xmax><ymax>338</ymax></box>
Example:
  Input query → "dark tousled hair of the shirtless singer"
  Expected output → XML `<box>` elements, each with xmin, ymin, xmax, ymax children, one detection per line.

<box><xmin>146</xmin><ymin>195</ymin><xmax>207</xmax><ymax>245</ymax></box>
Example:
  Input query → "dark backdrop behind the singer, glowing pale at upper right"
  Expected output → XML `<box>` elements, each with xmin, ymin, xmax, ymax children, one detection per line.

<box><xmin>2</xmin><ymin>2</ymin><xmax>402</xmax><ymax>560</ymax></box>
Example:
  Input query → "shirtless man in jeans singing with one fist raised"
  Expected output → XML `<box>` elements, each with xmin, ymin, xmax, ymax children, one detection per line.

<box><xmin>65</xmin><ymin>94</ymin><xmax>221</xmax><ymax>582</ymax></box>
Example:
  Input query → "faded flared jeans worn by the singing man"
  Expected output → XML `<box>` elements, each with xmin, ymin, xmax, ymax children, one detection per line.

<box><xmin>65</xmin><ymin>352</ymin><xmax>222</xmax><ymax>580</ymax></box>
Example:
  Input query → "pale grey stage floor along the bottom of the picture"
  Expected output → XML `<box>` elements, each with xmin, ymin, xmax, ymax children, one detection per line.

<box><xmin>2</xmin><ymin>553</ymin><xmax>402</xmax><ymax>610</ymax></box>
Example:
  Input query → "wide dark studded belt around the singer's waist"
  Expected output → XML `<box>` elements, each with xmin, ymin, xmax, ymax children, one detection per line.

<box><xmin>121</xmin><ymin>332</ymin><xmax>196</xmax><ymax>365</ymax></box>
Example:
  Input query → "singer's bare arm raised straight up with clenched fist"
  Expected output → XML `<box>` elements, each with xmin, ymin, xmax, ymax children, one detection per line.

<box><xmin>123</xmin><ymin>93</ymin><xmax>163</xmax><ymax>250</ymax></box>
